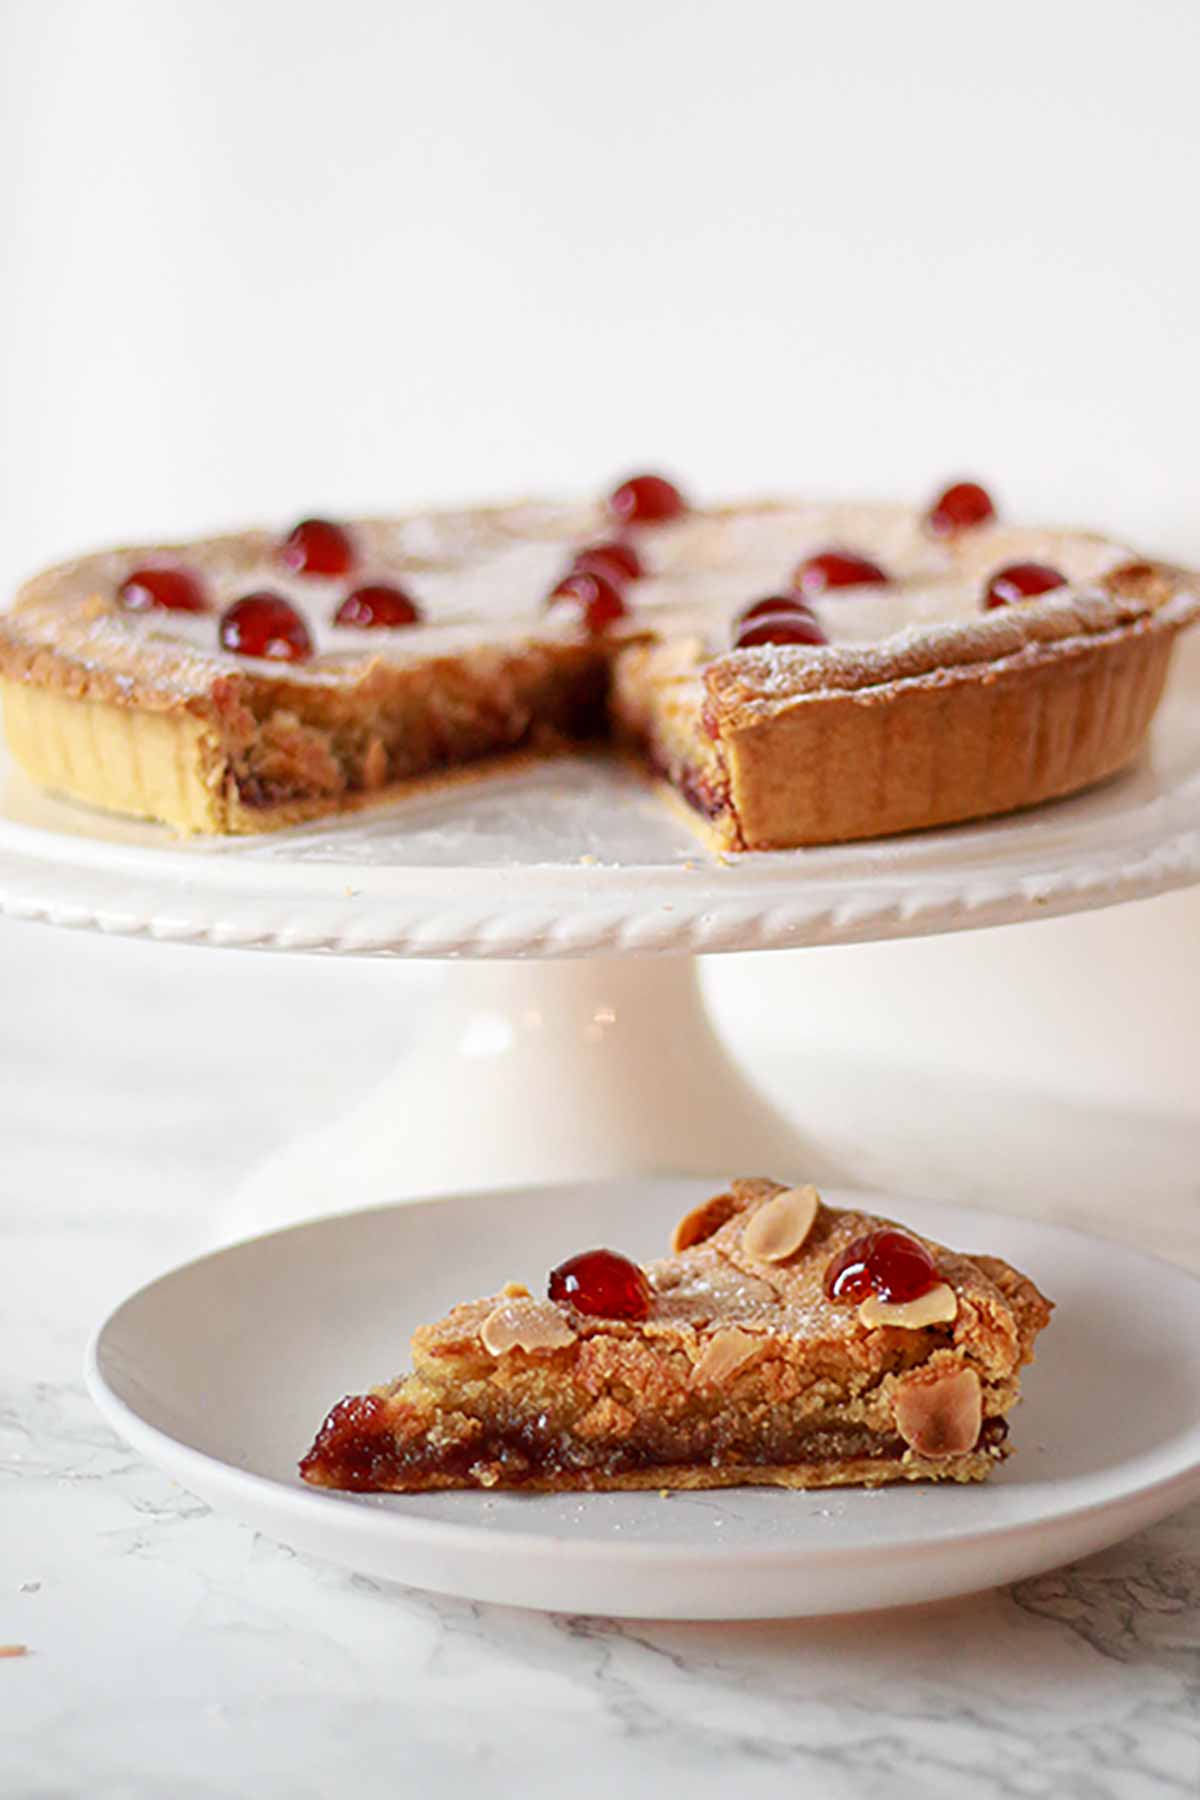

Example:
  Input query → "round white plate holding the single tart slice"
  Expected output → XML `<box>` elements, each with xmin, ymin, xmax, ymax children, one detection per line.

<box><xmin>88</xmin><ymin>1179</ymin><xmax>1200</xmax><ymax>1618</ymax></box>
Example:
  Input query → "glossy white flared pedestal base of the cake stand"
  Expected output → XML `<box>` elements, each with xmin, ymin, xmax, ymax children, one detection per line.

<box><xmin>218</xmin><ymin>956</ymin><xmax>837</xmax><ymax>1235</ymax></box>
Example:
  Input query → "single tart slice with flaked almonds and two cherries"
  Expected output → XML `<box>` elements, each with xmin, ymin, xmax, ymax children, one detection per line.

<box><xmin>300</xmin><ymin>1179</ymin><xmax>1051</xmax><ymax>1494</ymax></box>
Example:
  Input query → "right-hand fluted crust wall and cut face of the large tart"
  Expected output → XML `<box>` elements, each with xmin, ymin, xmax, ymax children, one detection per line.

<box><xmin>613</xmin><ymin>563</ymin><xmax>1200</xmax><ymax>850</ymax></box>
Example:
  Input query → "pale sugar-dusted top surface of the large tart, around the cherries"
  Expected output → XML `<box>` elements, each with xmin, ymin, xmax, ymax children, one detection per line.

<box><xmin>0</xmin><ymin>500</ymin><xmax>1165</xmax><ymax>706</ymax></box>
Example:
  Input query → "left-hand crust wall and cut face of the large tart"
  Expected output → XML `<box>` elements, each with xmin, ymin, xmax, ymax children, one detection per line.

<box><xmin>0</xmin><ymin>621</ymin><xmax>606</xmax><ymax>835</ymax></box>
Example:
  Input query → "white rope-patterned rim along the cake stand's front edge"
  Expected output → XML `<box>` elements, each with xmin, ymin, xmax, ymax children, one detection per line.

<box><xmin>0</xmin><ymin>828</ymin><xmax>1200</xmax><ymax>959</ymax></box>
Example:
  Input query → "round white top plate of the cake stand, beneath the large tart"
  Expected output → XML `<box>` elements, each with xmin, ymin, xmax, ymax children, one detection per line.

<box><xmin>0</xmin><ymin>684</ymin><xmax>1200</xmax><ymax>958</ymax></box>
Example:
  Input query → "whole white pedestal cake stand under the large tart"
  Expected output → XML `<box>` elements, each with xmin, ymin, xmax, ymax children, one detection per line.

<box><xmin>0</xmin><ymin>688</ymin><xmax>1200</xmax><ymax>1231</ymax></box>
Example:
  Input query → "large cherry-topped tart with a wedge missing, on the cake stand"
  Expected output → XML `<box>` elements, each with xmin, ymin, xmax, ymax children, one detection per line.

<box><xmin>0</xmin><ymin>475</ymin><xmax>1200</xmax><ymax>850</ymax></box>
